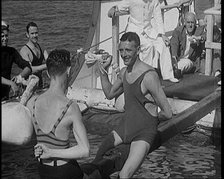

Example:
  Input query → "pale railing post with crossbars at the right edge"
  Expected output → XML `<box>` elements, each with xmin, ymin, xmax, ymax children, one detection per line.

<box><xmin>204</xmin><ymin>6</ymin><xmax>221</xmax><ymax>75</ymax></box>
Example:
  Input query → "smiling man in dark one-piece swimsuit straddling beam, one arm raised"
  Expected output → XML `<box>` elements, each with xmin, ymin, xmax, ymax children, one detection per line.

<box><xmin>93</xmin><ymin>32</ymin><xmax>172</xmax><ymax>178</ymax></box>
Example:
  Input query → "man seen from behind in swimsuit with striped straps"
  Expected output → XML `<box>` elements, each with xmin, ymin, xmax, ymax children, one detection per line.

<box><xmin>27</xmin><ymin>50</ymin><xmax>90</xmax><ymax>179</ymax></box>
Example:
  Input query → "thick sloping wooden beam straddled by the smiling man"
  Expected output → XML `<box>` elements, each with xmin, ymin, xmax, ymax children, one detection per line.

<box><xmin>81</xmin><ymin>89</ymin><xmax>221</xmax><ymax>178</ymax></box>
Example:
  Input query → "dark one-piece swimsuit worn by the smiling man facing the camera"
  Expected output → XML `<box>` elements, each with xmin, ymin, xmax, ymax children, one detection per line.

<box><xmin>115</xmin><ymin>69</ymin><xmax>158</xmax><ymax>145</ymax></box>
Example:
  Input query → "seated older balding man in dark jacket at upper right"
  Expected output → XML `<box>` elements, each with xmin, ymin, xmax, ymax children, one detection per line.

<box><xmin>170</xmin><ymin>12</ymin><xmax>206</xmax><ymax>74</ymax></box>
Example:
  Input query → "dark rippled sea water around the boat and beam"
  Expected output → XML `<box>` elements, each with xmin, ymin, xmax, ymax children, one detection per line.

<box><xmin>1</xmin><ymin>0</ymin><xmax>221</xmax><ymax>179</ymax></box>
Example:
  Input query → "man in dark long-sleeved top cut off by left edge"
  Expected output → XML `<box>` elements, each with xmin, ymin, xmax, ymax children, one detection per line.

<box><xmin>1</xmin><ymin>21</ymin><xmax>32</xmax><ymax>101</ymax></box>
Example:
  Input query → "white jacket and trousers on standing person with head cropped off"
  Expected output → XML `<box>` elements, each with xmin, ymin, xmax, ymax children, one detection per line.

<box><xmin>117</xmin><ymin>0</ymin><xmax>174</xmax><ymax>80</ymax></box>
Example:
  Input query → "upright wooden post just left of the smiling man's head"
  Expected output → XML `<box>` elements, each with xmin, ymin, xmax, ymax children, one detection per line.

<box><xmin>111</xmin><ymin>15</ymin><xmax>119</xmax><ymax>84</ymax></box>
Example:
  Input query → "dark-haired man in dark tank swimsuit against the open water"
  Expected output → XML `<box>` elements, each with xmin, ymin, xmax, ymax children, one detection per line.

<box><xmin>20</xmin><ymin>22</ymin><xmax>48</xmax><ymax>88</ymax></box>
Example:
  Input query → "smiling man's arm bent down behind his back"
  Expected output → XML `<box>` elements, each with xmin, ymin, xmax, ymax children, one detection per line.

<box><xmin>144</xmin><ymin>72</ymin><xmax>172</xmax><ymax>120</ymax></box>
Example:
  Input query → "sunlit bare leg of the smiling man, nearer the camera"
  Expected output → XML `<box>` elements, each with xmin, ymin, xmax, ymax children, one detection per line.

<box><xmin>119</xmin><ymin>140</ymin><xmax>150</xmax><ymax>178</ymax></box>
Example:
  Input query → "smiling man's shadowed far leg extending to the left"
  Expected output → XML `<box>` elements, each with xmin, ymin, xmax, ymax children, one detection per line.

<box><xmin>92</xmin><ymin>131</ymin><xmax>123</xmax><ymax>163</ymax></box>
